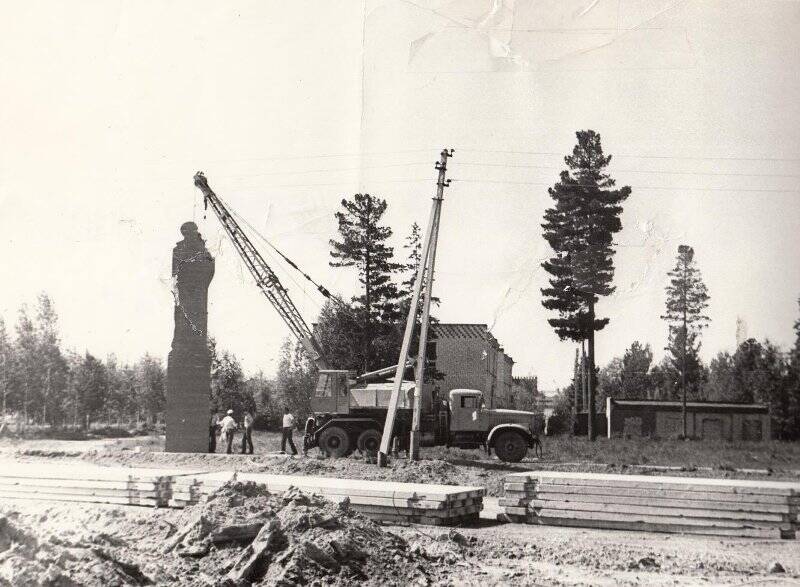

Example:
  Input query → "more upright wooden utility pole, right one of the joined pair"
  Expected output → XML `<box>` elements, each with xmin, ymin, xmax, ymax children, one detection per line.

<box><xmin>408</xmin><ymin>149</ymin><xmax>453</xmax><ymax>461</ymax></box>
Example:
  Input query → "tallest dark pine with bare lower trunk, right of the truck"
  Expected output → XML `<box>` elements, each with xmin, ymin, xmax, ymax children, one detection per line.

<box><xmin>542</xmin><ymin>130</ymin><xmax>631</xmax><ymax>440</ymax></box>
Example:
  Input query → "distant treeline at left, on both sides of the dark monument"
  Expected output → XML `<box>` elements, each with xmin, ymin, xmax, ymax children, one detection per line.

<box><xmin>0</xmin><ymin>293</ymin><xmax>300</xmax><ymax>429</ymax></box>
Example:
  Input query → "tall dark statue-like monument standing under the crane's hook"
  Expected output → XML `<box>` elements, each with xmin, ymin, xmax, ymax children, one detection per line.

<box><xmin>165</xmin><ymin>222</ymin><xmax>214</xmax><ymax>452</ymax></box>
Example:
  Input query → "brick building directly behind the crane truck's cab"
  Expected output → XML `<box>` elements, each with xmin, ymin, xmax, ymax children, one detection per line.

<box><xmin>427</xmin><ymin>323</ymin><xmax>514</xmax><ymax>408</ymax></box>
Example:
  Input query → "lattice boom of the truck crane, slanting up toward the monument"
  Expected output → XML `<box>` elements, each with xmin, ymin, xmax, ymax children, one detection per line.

<box><xmin>194</xmin><ymin>171</ymin><xmax>329</xmax><ymax>369</ymax></box>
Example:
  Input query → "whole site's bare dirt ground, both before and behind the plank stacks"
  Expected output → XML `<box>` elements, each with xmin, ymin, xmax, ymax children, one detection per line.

<box><xmin>0</xmin><ymin>433</ymin><xmax>800</xmax><ymax>585</ymax></box>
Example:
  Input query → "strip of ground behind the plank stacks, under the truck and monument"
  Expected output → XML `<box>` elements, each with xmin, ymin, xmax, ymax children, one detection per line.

<box><xmin>0</xmin><ymin>432</ymin><xmax>800</xmax><ymax>497</ymax></box>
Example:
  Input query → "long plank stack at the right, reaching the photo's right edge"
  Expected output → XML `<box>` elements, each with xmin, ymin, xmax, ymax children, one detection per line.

<box><xmin>500</xmin><ymin>471</ymin><xmax>800</xmax><ymax>538</ymax></box>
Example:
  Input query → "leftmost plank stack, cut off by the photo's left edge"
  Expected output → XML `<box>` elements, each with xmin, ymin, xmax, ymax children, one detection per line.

<box><xmin>0</xmin><ymin>461</ymin><xmax>180</xmax><ymax>507</ymax></box>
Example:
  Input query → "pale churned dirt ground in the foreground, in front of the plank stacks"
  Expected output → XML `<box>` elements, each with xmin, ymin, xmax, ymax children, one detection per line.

<box><xmin>0</xmin><ymin>496</ymin><xmax>800</xmax><ymax>586</ymax></box>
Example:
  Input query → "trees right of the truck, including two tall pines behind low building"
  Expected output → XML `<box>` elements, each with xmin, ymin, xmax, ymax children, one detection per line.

<box><xmin>542</xmin><ymin>130</ymin><xmax>800</xmax><ymax>439</ymax></box>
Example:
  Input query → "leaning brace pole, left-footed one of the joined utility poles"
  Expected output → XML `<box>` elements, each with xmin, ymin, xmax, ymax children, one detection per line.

<box><xmin>378</xmin><ymin>149</ymin><xmax>453</xmax><ymax>467</ymax></box>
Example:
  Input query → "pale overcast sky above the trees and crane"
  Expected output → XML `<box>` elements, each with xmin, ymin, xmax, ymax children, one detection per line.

<box><xmin>0</xmin><ymin>0</ymin><xmax>800</xmax><ymax>389</ymax></box>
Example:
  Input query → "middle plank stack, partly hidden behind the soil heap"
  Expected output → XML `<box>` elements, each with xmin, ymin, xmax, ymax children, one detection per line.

<box><xmin>180</xmin><ymin>473</ymin><xmax>485</xmax><ymax>526</ymax></box>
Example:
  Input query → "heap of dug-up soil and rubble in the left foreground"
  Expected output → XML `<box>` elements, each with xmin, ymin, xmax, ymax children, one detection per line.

<box><xmin>0</xmin><ymin>482</ymin><xmax>470</xmax><ymax>587</ymax></box>
